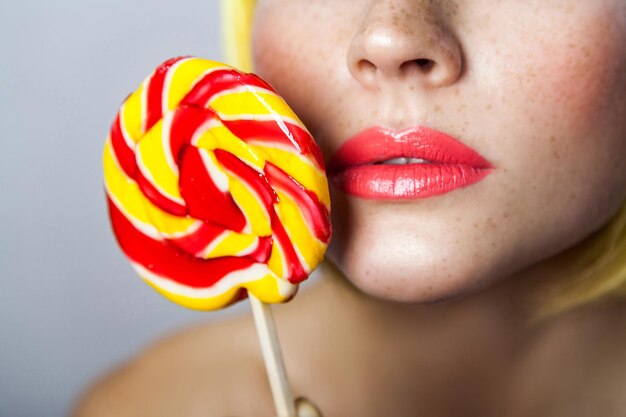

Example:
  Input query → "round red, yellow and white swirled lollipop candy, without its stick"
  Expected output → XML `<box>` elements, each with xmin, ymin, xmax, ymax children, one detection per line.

<box><xmin>104</xmin><ymin>57</ymin><xmax>330</xmax><ymax>310</ymax></box>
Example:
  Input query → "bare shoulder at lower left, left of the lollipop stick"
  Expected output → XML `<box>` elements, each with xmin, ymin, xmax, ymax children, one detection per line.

<box><xmin>74</xmin><ymin>312</ymin><xmax>271</xmax><ymax>417</ymax></box>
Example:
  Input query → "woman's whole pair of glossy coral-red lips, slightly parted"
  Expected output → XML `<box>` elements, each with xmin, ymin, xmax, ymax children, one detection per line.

<box><xmin>328</xmin><ymin>126</ymin><xmax>494</xmax><ymax>200</ymax></box>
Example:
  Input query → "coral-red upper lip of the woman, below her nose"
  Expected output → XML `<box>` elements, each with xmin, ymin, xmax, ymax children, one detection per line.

<box><xmin>328</xmin><ymin>126</ymin><xmax>493</xmax><ymax>173</ymax></box>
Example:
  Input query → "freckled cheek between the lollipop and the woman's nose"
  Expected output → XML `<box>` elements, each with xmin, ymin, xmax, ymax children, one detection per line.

<box><xmin>252</xmin><ymin>0</ymin><xmax>358</xmax><ymax>155</ymax></box>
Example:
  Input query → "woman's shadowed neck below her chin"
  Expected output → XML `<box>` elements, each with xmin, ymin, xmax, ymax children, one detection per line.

<box><xmin>281</xmin><ymin>256</ymin><xmax>580</xmax><ymax>415</ymax></box>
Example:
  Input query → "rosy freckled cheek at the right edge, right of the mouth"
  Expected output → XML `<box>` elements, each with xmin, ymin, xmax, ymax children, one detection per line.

<box><xmin>482</xmin><ymin>2</ymin><xmax>626</xmax><ymax>232</ymax></box>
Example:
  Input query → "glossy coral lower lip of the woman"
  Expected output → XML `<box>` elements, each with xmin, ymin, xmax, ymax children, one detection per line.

<box><xmin>331</xmin><ymin>164</ymin><xmax>492</xmax><ymax>199</ymax></box>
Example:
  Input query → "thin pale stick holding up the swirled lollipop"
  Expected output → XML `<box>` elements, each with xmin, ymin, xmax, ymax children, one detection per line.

<box><xmin>248</xmin><ymin>294</ymin><xmax>296</xmax><ymax>417</ymax></box>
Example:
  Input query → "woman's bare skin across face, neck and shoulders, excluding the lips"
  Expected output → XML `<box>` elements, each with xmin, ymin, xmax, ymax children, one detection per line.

<box><xmin>76</xmin><ymin>0</ymin><xmax>626</xmax><ymax>417</ymax></box>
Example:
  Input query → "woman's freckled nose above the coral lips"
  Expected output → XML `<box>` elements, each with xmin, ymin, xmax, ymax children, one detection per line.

<box><xmin>348</xmin><ymin>0</ymin><xmax>463</xmax><ymax>89</ymax></box>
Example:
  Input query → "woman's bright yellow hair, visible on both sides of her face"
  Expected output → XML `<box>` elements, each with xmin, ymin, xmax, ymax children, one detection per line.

<box><xmin>222</xmin><ymin>0</ymin><xmax>626</xmax><ymax>318</ymax></box>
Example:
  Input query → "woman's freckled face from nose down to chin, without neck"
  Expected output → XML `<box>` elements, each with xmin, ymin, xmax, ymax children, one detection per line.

<box><xmin>253</xmin><ymin>0</ymin><xmax>626</xmax><ymax>302</ymax></box>
